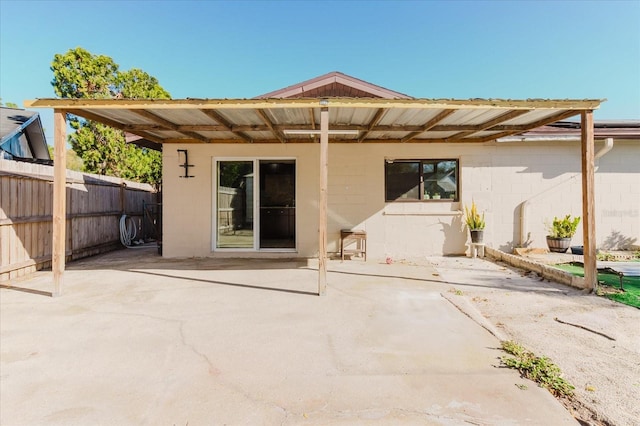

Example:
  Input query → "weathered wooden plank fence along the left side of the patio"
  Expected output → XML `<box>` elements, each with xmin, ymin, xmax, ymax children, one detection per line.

<box><xmin>0</xmin><ymin>160</ymin><xmax>156</xmax><ymax>282</ymax></box>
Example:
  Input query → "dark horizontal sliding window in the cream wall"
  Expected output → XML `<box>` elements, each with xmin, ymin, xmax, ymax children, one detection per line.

<box><xmin>384</xmin><ymin>160</ymin><xmax>459</xmax><ymax>201</ymax></box>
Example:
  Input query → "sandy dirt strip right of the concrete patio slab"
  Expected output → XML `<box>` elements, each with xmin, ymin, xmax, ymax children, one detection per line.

<box><xmin>429</xmin><ymin>257</ymin><xmax>640</xmax><ymax>425</ymax></box>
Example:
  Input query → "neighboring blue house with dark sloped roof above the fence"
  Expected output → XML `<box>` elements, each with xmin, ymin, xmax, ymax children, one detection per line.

<box><xmin>0</xmin><ymin>107</ymin><xmax>51</xmax><ymax>162</ymax></box>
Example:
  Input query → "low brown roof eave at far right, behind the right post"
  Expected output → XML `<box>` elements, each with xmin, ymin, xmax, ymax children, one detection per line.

<box><xmin>501</xmin><ymin>120</ymin><xmax>640</xmax><ymax>142</ymax></box>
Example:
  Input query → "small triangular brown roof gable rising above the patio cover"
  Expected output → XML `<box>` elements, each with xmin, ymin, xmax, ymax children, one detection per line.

<box><xmin>256</xmin><ymin>71</ymin><xmax>413</xmax><ymax>99</ymax></box>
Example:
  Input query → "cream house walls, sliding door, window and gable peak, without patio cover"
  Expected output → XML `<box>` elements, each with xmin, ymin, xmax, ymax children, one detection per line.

<box><xmin>158</xmin><ymin>73</ymin><xmax>640</xmax><ymax>259</ymax></box>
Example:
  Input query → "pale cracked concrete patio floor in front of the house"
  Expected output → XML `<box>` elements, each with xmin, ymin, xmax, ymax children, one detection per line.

<box><xmin>0</xmin><ymin>250</ymin><xmax>577</xmax><ymax>425</ymax></box>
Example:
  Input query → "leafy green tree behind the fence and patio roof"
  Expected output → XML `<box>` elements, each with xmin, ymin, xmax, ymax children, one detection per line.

<box><xmin>51</xmin><ymin>47</ymin><xmax>171</xmax><ymax>185</ymax></box>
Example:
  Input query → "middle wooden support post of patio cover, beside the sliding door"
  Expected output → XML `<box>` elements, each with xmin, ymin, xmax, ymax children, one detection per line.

<box><xmin>318</xmin><ymin>107</ymin><xmax>329</xmax><ymax>296</ymax></box>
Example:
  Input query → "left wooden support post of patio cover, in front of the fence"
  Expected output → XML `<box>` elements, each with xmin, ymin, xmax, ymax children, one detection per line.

<box><xmin>51</xmin><ymin>110</ymin><xmax>67</xmax><ymax>297</ymax></box>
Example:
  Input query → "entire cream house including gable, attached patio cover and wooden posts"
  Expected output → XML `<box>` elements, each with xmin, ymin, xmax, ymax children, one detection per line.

<box><xmin>25</xmin><ymin>72</ymin><xmax>624</xmax><ymax>294</ymax></box>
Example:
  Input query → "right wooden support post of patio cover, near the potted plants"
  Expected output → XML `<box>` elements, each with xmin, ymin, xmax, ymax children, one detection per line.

<box><xmin>581</xmin><ymin>111</ymin><xmax>598</xmax><ymax>291</ymax></box>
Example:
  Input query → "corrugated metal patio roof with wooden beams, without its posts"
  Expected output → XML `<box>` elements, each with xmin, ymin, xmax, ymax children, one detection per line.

<box><xmin>26</xmin><ymin>98</ymin><xmax>601</xmax><ymax>147</ymax></box>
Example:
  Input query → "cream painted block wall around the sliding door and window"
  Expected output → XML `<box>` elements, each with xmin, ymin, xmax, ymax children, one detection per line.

<box><xmin>163</xmin><ymin>141</ymin><xmax>640</xmax><ymax>259</ymax></box>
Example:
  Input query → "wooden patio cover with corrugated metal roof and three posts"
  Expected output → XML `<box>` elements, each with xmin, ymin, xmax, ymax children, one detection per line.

<box><xmin>25</xmin><ymin>97</ymin><xmax>602</xmax><ymax>295</ymax></box>
